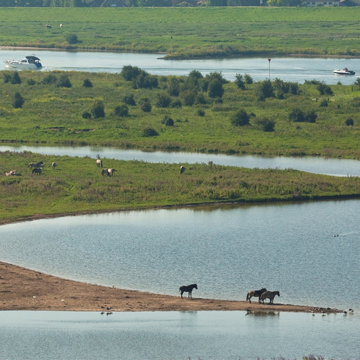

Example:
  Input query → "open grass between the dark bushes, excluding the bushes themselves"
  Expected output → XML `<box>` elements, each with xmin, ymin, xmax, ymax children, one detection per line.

<box><xmin>0</xmin><ymin>72</ymin><xmax>360</xmax><ymax>159</ymax></box>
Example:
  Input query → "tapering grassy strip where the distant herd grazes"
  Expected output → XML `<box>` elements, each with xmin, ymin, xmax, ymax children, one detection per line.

<box><xmin>0</xmin><ymin>152</ymin><xmax>360</xmax><ymax>224</ymax></box>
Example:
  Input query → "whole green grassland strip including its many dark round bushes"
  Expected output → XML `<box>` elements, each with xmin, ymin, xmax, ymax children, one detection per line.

<box><xmin>0</xmin><ymin>70</ymin><xmax>360</xmax><ymax>159</ymax></box>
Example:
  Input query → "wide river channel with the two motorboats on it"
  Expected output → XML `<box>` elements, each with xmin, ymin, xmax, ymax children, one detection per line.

<box><xmin>0</xmin><ymin>50</ymin><xmax>360</xmax><ymax>85</ymax></box>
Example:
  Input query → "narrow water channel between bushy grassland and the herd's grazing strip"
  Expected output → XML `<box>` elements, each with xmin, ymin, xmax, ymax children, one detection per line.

<box><xmin>0</xmin><ymin>145</ymin><xmax>360</xmax><ymax>176</ymax></box>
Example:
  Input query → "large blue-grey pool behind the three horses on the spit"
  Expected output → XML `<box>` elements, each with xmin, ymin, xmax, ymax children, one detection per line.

<box><xmin>0</xmin><ymin>200</ymin><xmax>360</xmax><ymax>311</ymax></box>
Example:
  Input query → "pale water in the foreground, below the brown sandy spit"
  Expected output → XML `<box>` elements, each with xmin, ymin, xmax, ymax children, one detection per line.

<box><xmin>0</xmin><ymin>311</ymin><xmax>360</xmax><ymax>360</ymax></box>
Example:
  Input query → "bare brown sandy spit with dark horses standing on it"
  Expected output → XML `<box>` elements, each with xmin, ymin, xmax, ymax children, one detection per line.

<box><xmin>0</xmin><ymin>261</ymin><xmax>343</xmax><ymax>313</ymax></box>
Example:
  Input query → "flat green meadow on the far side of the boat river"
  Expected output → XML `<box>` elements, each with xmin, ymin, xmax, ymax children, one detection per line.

<box><xmin>0</xmin><ymin>7</ymin><xmax>360</xmax><ymax>58</ymax></box>
